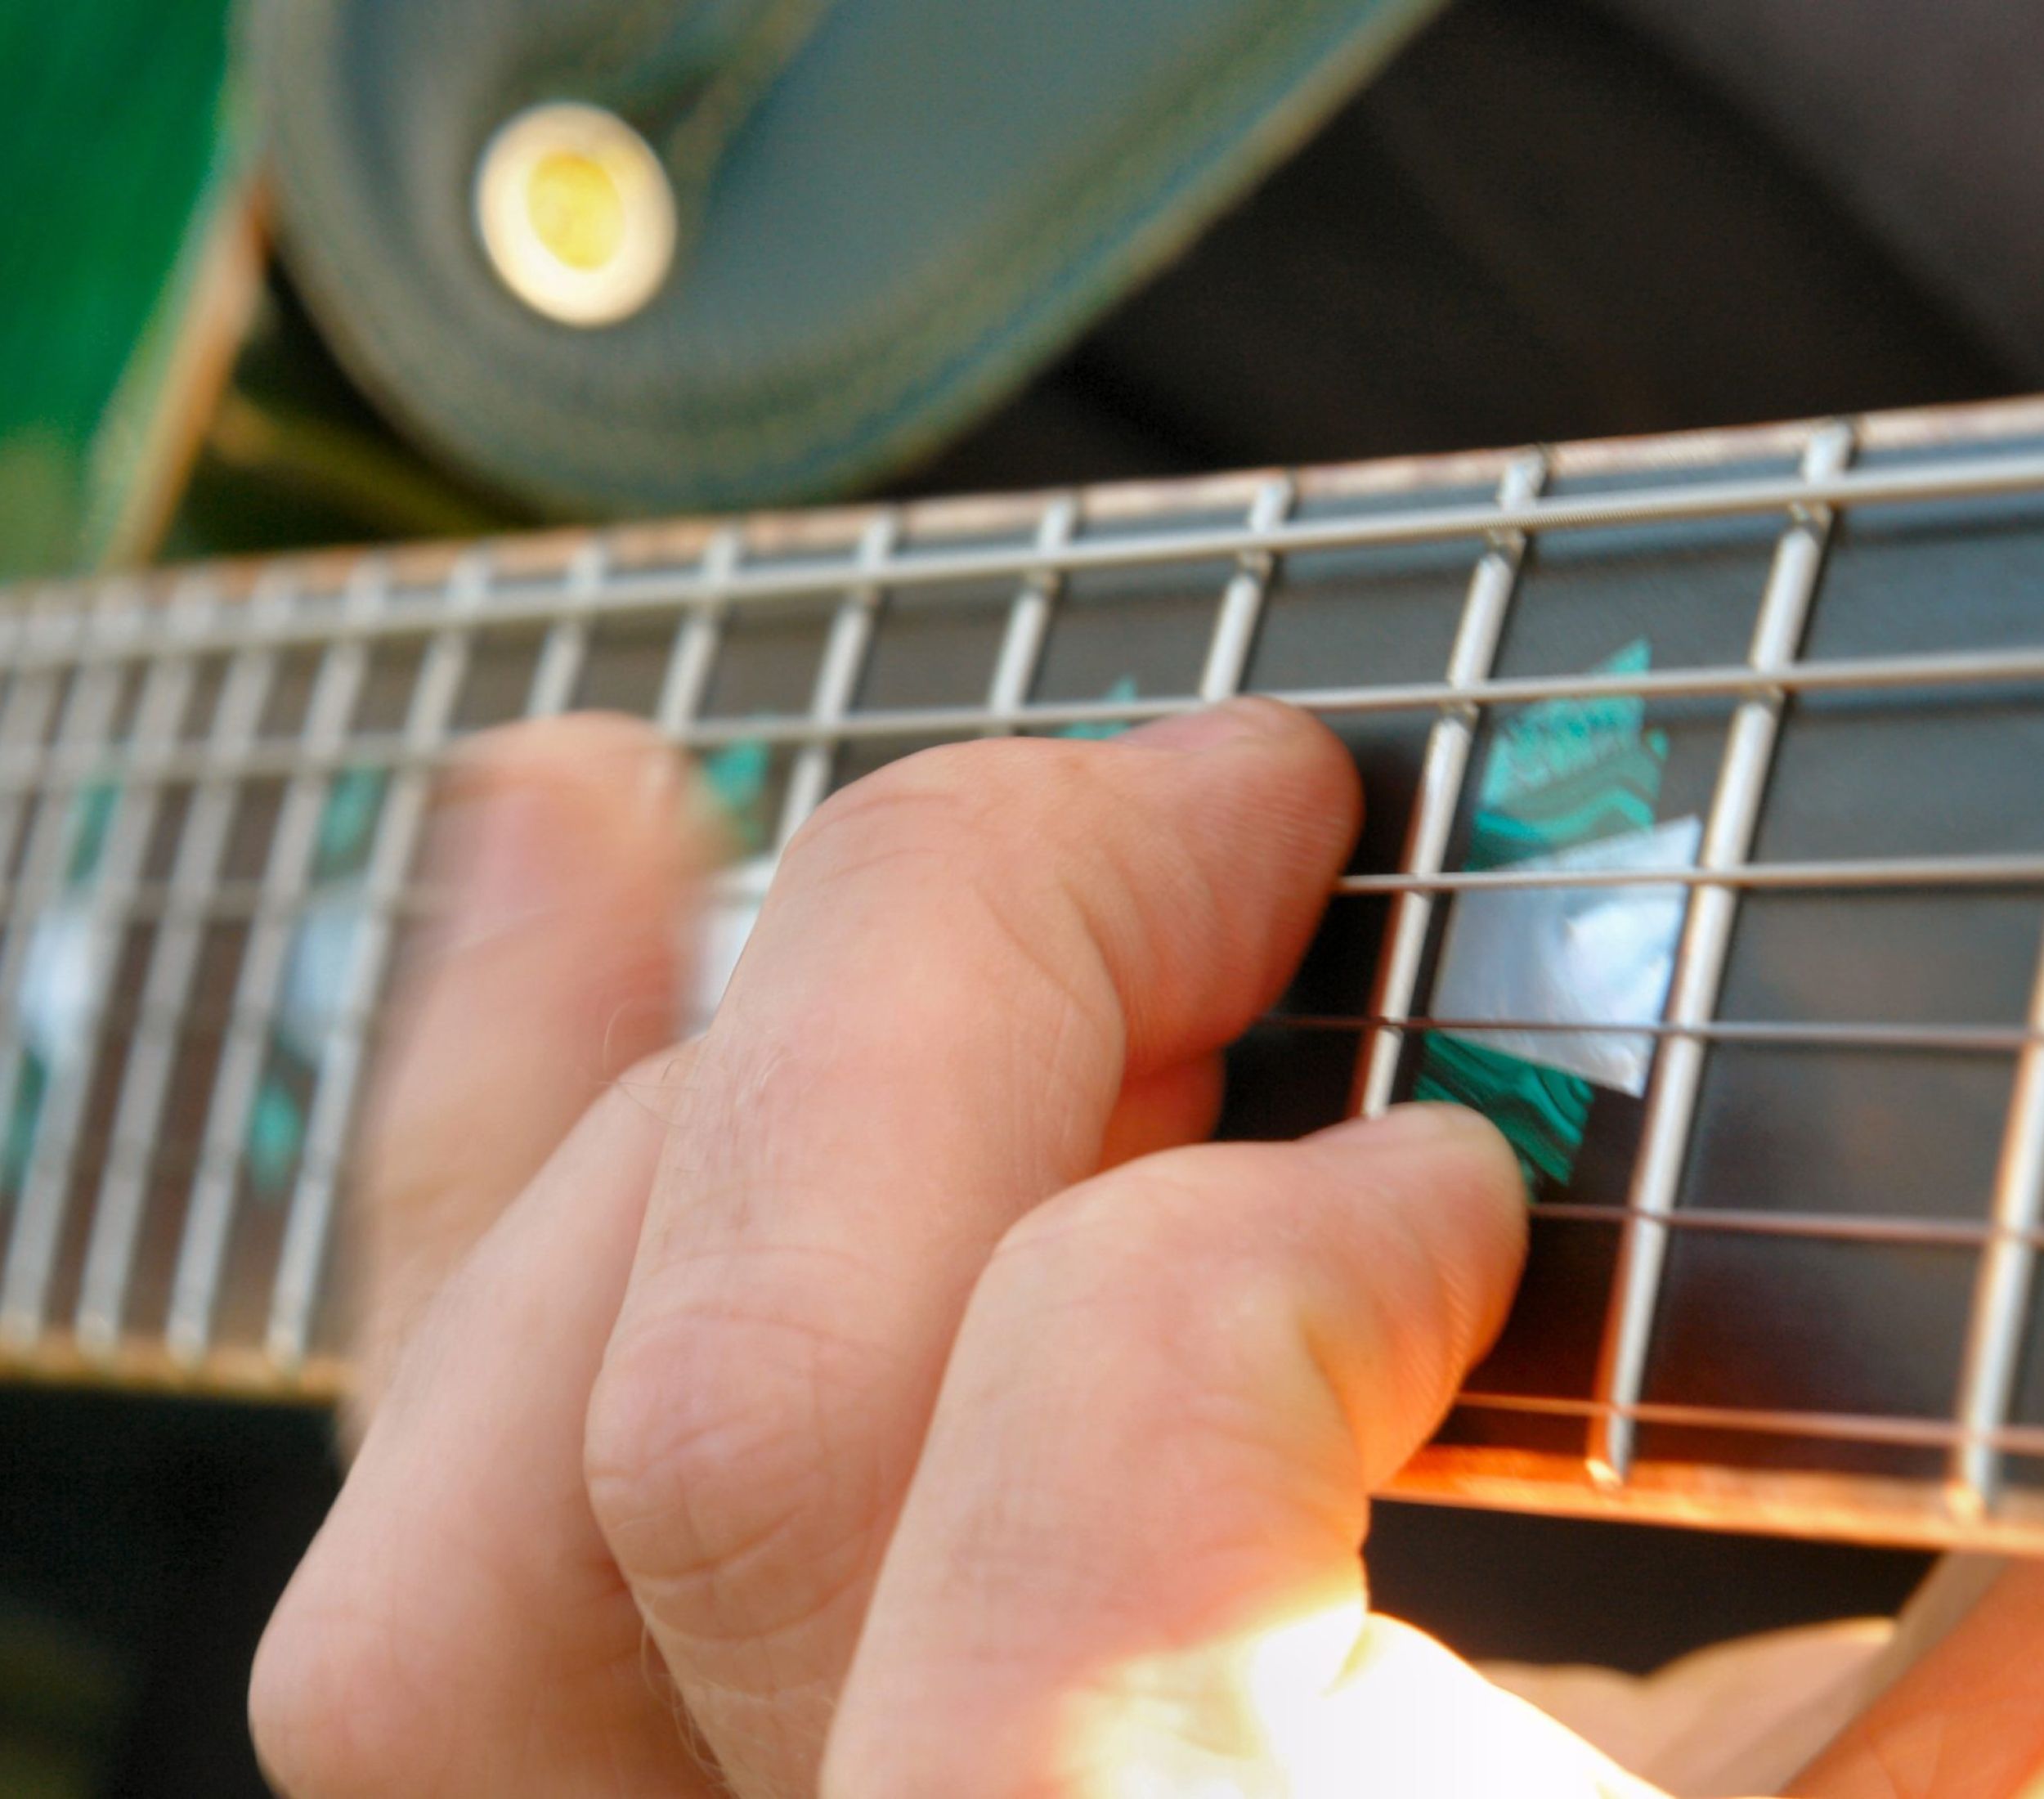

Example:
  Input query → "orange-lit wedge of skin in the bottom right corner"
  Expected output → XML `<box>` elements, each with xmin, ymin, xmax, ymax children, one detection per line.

<box><xmin>1789</xmin><ymin>1562</ymin><xmax>2044</xmax><ymax>1799</ymax></box>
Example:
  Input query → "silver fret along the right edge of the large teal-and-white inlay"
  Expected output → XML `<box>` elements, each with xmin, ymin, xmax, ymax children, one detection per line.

<box><xmin>1589</xmin><ymin>425</ymin><xmax>1852</xmax><ymax>1484</ymax></box>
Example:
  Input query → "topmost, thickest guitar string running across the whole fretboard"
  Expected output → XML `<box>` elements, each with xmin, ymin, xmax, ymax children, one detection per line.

<box><xmin>19</xmin><ymin>456</ymin><xmax>2044</xmax><ymax>671</ymax></box>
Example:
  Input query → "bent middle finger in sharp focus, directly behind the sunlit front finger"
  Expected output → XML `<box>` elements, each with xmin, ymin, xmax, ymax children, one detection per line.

<box><xmin>589</xmin><ymin>703</ymin><xmax>1360</xmax><ymax>1795</ymax></box>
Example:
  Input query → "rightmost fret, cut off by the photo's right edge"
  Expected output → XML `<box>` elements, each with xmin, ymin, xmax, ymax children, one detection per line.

<box><xmin>1952</xmin><ymin>928</ymin><xmax>2044</xmax><ymax>1511</ymax></box>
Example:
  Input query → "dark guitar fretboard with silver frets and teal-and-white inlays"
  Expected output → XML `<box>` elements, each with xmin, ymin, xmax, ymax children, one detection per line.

<box><xmin>0</xmin><ymin>403</ymin><xmax>2044</xmax><ymax>1548</ymax></box>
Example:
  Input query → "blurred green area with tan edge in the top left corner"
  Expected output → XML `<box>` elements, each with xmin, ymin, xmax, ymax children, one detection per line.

<box><xmin>0</xmin><ymin>0</ymin><xmax>256</xmax><ymax>576</ymax></box>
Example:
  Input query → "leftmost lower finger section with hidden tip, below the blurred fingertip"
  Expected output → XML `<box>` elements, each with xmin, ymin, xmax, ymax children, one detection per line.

<box><xmin>249</xmin><ymin>1063</ymin><xmax>722</xmax><ymax>1799</ymax></box>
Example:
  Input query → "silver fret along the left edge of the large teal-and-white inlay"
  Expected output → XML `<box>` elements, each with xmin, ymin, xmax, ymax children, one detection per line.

<box><xmin>1353</xmin><ymin>454</ymin><xmax>1548</xmax><ymax>1119</ymax></box>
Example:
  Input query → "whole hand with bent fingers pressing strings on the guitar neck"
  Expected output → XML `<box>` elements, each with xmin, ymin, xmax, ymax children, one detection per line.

<box><xmin>252</xmin><ymin>706</ymin><xmax>2014</xmax><ymax>1799</ymax></box>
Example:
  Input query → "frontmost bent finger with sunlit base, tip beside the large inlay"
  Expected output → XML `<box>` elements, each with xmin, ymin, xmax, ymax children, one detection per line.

<box><xmin>822</xmin><ymin>1106</ymin><xmax>1525</xmax><ymax>1799</ymax></box>
